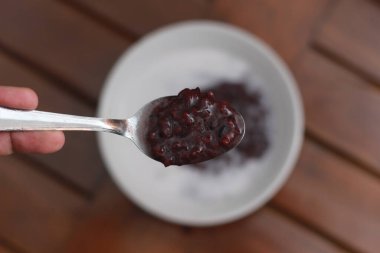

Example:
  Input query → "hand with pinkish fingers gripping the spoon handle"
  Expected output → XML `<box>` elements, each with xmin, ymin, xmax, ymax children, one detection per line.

<box><xmin>0</xmin><ymin>86</ymin><xmax>65</xmax><ymax>155</ymax></box>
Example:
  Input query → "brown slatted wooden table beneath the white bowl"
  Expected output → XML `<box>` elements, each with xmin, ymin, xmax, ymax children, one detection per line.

<box><xmin>0</xmin><ymin>0</ymin><xmax>380</xmax><ymax>253</ymax></box>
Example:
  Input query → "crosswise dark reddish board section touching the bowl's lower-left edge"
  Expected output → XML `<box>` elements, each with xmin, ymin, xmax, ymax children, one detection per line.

<box><xmin>67</xmin><ymin>178</ymin><xmax>185</xmax><ymax>253</ymax></box>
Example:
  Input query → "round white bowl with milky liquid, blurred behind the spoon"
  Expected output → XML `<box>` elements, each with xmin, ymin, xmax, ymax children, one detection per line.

<box><xmin>99</xmin><ymin>21</ymin><xmax>304</xmax><ymax>226</ymax></box>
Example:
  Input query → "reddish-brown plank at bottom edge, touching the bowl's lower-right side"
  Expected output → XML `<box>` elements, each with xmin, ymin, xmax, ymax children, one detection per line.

<box><xmin>189</xmin><ymin>208</ymin><xmax>344</xmax><ymax>253</ymax></box>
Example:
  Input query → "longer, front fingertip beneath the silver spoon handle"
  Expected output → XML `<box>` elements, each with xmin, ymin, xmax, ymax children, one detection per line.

<box><xmin>10</xmin><ymin>131</ymin><xmax>65</xmax><ymax>154</ymax></box>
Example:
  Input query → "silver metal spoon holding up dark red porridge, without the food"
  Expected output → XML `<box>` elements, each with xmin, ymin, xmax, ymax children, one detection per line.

<box><xmin>0</xmin><ymin>97</ymin><xmax>245</xmax><ymax>165</ymax></box>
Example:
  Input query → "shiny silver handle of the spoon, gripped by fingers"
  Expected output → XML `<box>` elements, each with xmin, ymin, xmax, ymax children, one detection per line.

<box><xmin>0</xmin><ymin>107</ymin><xmax>121</xmax><ymax>133</ymax></box>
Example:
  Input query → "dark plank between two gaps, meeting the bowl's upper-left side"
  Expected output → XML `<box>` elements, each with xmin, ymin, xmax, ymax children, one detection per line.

<box><xmin>0</xmin><ymin>0</ymin><xmax>129</xmax><ymax>100</ymax></box>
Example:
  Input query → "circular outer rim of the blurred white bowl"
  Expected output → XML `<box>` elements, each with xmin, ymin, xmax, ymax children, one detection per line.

<box><xmin>97</xmin><ymin>20</ymin><xmax>304</xmax><ymax>227</ymax></box>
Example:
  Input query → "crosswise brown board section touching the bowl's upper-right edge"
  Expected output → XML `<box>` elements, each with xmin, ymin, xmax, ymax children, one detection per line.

<box><xmin>215</xmin><ymin>0</ymin><xmax>330</xmax><ymax>62</ymax></box>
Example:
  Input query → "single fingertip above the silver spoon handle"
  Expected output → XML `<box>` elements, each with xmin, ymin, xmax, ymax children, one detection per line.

<box><xmin>0</xmin><ymin>86</ymin><xmax>38</xmax><ymax>110</ymax></box>
